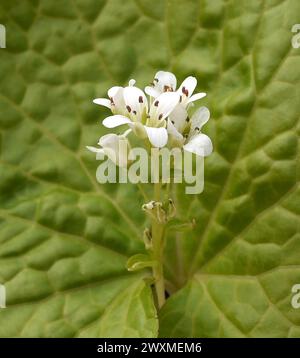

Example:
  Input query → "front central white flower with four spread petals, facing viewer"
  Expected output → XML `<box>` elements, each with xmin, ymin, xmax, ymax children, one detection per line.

<box><xmin>102</xmin><ymin>86</ymin><xmax>180</xmax><ymax>148</ymax></box>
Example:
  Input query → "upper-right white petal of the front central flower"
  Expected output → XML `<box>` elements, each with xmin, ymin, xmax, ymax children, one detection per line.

<box><xmin>149</xmin><ymin>92</ymin><xmax>180</xmax><ymax>120</ymax></box>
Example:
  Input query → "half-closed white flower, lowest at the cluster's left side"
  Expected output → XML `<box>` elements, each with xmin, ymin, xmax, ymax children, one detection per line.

<box><xmin>87</xmin><ymin>129</ymin><xmax>131</xmax><ymax>167</ymax></box>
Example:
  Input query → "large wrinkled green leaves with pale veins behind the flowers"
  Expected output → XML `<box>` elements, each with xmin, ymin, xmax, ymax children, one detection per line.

<box><xmin>0</xmin><ymin>0</ymin><xmax>300</xmax><ymax>337</ymax></box>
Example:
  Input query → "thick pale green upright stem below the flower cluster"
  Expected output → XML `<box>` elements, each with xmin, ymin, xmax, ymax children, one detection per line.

<box><xmin>152</xmin><ymin>183</ymin><xmax>165</xmax><ymax>308</ymax></box>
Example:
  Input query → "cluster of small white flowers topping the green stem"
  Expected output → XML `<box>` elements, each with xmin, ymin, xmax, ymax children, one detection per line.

<box><xmin>87</xmin><ymin>71</ymin><xmax>212</xmax><ymax>166</ymax></box>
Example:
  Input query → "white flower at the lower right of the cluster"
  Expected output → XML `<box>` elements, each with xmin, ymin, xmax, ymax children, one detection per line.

<box><xmin>167</xmin><ymin>107</ymin><xmax>213</xmax><ymax>157</ymax></box>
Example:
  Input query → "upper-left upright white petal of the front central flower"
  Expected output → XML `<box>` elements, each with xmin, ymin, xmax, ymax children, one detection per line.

<box><xmin>123</xmin><ymin>86</ymin><xmax>148</xmax><ymax>119</ymax></box>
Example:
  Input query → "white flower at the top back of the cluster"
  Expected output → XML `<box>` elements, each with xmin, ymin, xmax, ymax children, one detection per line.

<box><xmin>145</xmin><ymin>71</ymin><xmax>206</xmax><ymax>107</ymax></box>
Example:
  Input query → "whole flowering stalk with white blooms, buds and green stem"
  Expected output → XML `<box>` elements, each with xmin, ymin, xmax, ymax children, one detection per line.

<box><xmin>87</xmin><ymin>71</ymin><xmax>213</xmax><ymax>308</ymax></box>
